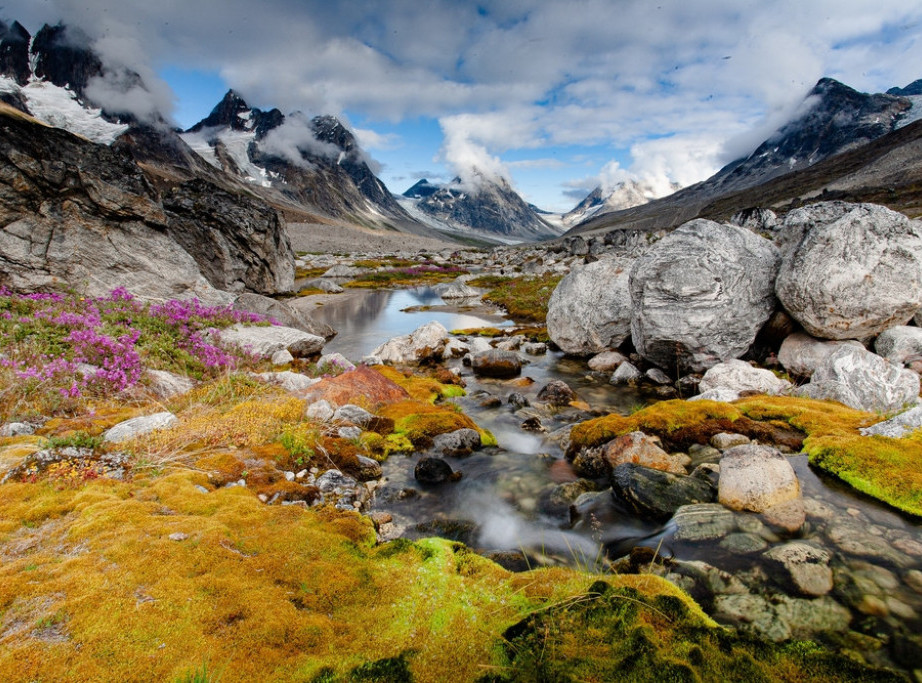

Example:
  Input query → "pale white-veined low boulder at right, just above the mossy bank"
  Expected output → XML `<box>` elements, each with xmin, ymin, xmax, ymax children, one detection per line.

<box><xmin>798</xmin><ymin>346</ymin><xmax>919</xmax><ymax>413</ymax></box>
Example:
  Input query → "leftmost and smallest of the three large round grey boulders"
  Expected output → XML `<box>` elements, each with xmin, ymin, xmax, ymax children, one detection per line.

<box><xmin>547</xmin><ymin>258</ymin><xmax>631</xmax><ymax>356</ymax></box>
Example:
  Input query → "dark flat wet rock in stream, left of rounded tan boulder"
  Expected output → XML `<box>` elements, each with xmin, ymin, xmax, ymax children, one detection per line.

<box><xmin>611</xmin><ymin>463</ymin><xmax>717</xmax><ymax>521</ymax></box>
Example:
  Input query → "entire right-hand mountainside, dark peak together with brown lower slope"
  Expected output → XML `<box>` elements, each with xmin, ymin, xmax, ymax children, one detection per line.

<box><xmin>568</xmin><ymin>78</ymin><xmax>922</xmax><ymax>234</ymax></box>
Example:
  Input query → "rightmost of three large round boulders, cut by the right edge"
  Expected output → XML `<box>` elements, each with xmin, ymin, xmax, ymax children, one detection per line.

<box><xmin>776</xmin><ymin>202</ymin><xmax>922</xmax><ymax>339</ymax></box>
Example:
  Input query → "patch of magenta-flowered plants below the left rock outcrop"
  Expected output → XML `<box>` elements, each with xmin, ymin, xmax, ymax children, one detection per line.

<box><xmin>0</xmin><ymin>288</ymin><xmax>269</xmax><ymax>417</ymax></box>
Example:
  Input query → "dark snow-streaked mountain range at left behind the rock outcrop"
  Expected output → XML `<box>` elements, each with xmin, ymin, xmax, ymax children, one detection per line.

<box><xmin>0</xmin><ymin>22</ymin><xmax>419</xmax><ymax>230</ymax></box>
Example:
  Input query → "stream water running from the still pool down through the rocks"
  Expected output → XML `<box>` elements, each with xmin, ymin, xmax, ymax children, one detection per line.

<box><xmin>311</xmin><ymin>288</ymin><xmax>922</xmax><ymax>669</ymax></box>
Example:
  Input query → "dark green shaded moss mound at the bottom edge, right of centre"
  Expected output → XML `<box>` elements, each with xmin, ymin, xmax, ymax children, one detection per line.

<box><xmin>479</xmin><ymin>581</ymin><xmax>905</xmax><ymax>683</ymax></box>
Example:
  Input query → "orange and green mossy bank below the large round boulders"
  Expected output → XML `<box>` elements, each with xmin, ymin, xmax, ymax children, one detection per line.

<box><xmin>569</xmin><ymin>396</ymin><xmax>922</xmax><ymax>516</ymax></box>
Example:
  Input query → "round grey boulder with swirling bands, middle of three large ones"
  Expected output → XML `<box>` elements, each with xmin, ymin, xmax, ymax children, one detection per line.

<box><xmin>630</xmin><ymin>219</ymin><xmax>780</xmax><ymax>371</ymax></box>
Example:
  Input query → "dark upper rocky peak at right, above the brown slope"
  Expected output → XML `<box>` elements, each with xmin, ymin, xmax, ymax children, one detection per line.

<box><xmin>572</xmin><ymin>78</ymin><xmax>920</xmax><ymax>232</ymax></box>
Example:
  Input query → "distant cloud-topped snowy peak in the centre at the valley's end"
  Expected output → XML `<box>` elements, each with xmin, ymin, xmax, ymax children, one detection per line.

<box><xmin>401</xmin><ymin>171</ymin><xmax>559</xmax><ymax>243</ymax></box>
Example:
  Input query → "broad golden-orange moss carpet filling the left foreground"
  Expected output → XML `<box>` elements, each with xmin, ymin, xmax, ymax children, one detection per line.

<box><xmin>0</xmin><ymin>472</ymin><xmax>760</xmax><ymax>683</ymax></box>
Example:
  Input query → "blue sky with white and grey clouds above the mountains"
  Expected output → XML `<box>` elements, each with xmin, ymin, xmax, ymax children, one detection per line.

<box><xmin>2</xmin><ymin>0</ymin><xmax>922</xmax><ymax>211</ymax></box>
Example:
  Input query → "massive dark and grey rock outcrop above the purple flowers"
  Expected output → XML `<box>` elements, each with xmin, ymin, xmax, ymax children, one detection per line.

<box><xmin>0</xmin><ymin>108</ymin><xmax>294</xmax><ymax>302</ymax></box>
